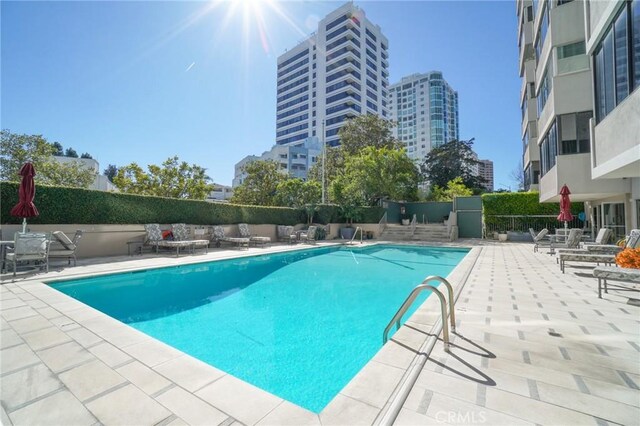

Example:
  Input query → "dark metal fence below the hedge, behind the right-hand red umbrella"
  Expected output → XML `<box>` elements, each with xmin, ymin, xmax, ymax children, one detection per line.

<box><xmin>484</xmin><ymin>214</ymin><xmax>584</xmax><ymax>238</ymax></box>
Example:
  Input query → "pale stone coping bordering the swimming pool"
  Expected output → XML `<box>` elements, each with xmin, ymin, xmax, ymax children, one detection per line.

<box><xmin>3</xmin><ymin>241</ymin><xmax>481</xmax><ymax>424</ymax></box>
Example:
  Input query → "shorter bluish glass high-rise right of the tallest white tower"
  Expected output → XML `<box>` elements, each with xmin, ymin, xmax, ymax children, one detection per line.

<box><xmin>389</xmin><ymin>71</ymin><xmax>459</xmax><ymax>161</ymax></box>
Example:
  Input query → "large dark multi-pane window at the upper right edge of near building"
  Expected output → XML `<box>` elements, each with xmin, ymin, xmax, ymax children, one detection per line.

<box><xmin>593</xmin><ymin>0</ymin><xmax>640</xmax><ymax>122</ymax></box>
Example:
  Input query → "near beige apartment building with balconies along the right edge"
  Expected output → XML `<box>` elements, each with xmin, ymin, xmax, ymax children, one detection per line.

<box><xmin>517</xmin><ymin>0</ymin><xmax>640</xmax><ymax>236</ymax></box>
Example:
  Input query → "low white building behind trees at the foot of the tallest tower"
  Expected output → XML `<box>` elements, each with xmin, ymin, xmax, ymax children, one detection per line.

<box><xmin>232</xmin><ymin>137</ymin><xmax>322</xmax><ymax>188</ymax></box>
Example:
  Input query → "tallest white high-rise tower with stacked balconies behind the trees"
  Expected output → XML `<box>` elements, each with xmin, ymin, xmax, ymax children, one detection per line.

<box><xmin>276</xmin><ymin>2</ymin><xmax>389</xmax><ymax>146</ymax></box>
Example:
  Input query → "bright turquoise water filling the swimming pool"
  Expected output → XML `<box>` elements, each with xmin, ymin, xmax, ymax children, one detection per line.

<box><xmin>52</xmin><ymin>245</ymin><xmax>468</xmax><ymax>412</ymax></box>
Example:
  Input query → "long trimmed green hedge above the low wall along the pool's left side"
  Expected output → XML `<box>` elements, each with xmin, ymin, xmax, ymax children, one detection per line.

<box><xmin>0</xmin><ymin>182</ymin><xmax>384</xmax><ymax>225</ymax></box>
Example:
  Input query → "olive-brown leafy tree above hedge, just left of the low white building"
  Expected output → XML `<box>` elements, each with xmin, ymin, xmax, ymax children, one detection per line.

<box><xmin>226</xmin><ymin>160</ymin><xmax>288</xmax><ymax>206</ymax></box>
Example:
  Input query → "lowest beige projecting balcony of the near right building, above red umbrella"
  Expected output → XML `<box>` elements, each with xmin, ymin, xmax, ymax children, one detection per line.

<box><xmin>540</xmin><ymin>153</ymin><xmax>631</xmax><ymax>203</ymax></box>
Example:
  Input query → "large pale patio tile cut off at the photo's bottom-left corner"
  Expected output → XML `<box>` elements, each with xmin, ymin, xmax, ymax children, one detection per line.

<box><xmin>9</xmin><ymin>390</ymin><xmax>96</xmax><ymax>426</ymax></box>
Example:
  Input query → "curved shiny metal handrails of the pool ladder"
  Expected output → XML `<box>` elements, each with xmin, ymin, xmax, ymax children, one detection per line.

<box><xmin>382</xmin><ymin>275</ymin><xmax>456</xmax><ymax>352</ymax></box>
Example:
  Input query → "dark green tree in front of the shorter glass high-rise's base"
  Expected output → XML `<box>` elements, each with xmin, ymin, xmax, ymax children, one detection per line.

<box><xmin>421</xmin><ymin>139</ymin><xmax>485</xmax><ymax>188</ymax></box>
